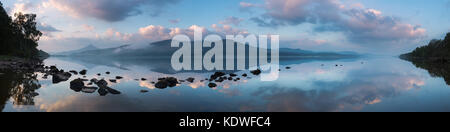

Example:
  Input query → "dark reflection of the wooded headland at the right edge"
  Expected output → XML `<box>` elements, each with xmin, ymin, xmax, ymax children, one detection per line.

<box><xmin>409</xmin><ymin>60</ymin><xmax>450</xmax><ymax>85</ymax></box>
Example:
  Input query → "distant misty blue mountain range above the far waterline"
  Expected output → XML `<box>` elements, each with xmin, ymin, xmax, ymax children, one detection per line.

<box><xmin>52</xmin><ymin>40</ymin><xmax>360</xmax><ymax>58</ymax></box>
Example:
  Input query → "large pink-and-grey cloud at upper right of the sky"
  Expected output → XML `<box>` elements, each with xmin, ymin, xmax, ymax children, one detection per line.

<box><xmin>251</xmin><ymin>0</ymin><xmax>426</xmax><ymax>44</ymax></box>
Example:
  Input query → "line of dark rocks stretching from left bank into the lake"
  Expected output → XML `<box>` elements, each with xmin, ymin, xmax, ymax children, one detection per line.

<box><xmin>0</xmin><ymin>58</ymin><xmax>298</xmax><ymax>96</ymax></box>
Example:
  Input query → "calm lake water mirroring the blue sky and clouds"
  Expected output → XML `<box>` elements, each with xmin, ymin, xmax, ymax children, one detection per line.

<box><xmin>0</xmin><ymin>57</ymin><xmax>450</xmax><ymax>112</ymax></box>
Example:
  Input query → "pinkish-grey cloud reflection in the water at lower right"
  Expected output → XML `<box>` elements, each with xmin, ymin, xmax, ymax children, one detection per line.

<box><xmin>248</xmin><ymin>70</ymin><xmax>425</xmax><ymax>112</ymax></box>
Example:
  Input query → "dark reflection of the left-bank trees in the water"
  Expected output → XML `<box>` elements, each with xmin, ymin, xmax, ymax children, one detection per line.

<box><xmin>0</xmin><ymin>71</ymin><xmax>41</xmax><ymax>111</ymax></box>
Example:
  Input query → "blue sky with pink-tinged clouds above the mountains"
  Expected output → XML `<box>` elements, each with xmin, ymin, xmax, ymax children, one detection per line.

<box><xmin>0</xmin><ymin>0</ymin><xmax>450</xmax><ymax>55</ymax></box>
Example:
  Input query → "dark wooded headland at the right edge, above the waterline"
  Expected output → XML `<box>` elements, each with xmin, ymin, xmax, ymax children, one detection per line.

<box><xmin>400</xmin><ymin>33</ymin><xmax>450</xmax><ymax>62</ymax></box>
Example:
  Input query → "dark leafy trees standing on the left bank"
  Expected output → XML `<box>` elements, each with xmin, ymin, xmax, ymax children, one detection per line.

<box><xmin>0</xmin><ymin>3</ymin><xmax>42</xmax><ymax>58</ymax></box>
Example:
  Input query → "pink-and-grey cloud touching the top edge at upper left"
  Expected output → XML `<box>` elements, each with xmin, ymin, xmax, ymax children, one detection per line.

<box><xmin>44</xmin><ymin>0</ymin><xmax>179</xmax><ymax>22</ymax></box>
